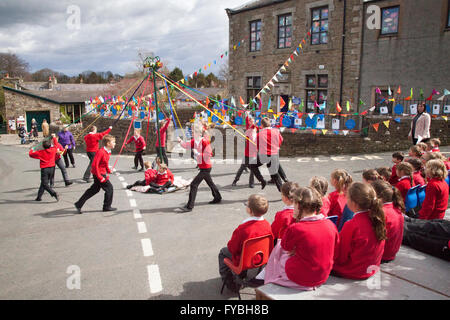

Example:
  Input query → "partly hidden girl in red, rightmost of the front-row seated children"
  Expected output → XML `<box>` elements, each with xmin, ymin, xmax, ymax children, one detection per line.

<box><xmin>372</xmin><ymin>181</ymin><xmax>405</xmax><ymax>263</ymax></box>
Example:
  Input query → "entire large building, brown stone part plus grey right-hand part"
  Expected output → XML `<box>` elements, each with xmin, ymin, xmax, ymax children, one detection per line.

<box><xmin>226</xmin><ymin>0</ymin><xmax>450</xmax><ymax>114</ymax></box>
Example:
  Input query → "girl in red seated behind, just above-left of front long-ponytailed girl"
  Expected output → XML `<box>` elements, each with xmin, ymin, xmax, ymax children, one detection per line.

<box><xmin>324</xmin><ymin>169</ymin><xmax>353</xmax><ymax>225</ymax></box>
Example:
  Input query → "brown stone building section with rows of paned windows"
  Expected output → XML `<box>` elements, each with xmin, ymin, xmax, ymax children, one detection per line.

<box><xmin>226</xmin><ymin>0</ymin><xmax>362</xmax><ymax>111</ymax></box>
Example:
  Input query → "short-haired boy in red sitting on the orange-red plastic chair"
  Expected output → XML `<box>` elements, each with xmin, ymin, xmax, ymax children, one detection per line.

<box><xmin>219</xmin><ymin>194</ymin><xmax>273</xmax><ymax>292</ymax></box>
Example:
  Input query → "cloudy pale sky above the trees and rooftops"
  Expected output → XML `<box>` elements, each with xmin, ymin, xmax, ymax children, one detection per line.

<box><xmin>0</xmin><ymin>0</ymin><xmax>249</xmax><ymax>76</ymax></box>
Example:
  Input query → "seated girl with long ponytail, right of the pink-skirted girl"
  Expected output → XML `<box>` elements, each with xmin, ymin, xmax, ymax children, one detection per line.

<box><xmin>333</xmin><ymin>182</ymin><xmax>386</xmax><ymax>279</ymax></box>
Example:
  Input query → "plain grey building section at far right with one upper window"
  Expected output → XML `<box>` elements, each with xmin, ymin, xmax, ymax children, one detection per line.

<box><xmin>359</xmin><ymin>0</ymin><xmax>450</xmax><ymax>114</ymax></box>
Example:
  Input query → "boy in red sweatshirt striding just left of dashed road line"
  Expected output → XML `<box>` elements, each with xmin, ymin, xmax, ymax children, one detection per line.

<box><xmin>75</xmin><ymin>135</ymin><xmax>117</xmax><ymax>214</ymax></box>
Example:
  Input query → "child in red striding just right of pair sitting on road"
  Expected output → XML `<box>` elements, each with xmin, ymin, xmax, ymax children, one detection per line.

<box><xmin>178</xmin><ymin>126</ymin><xmax>222</xmax><ymax>212</ymax></box>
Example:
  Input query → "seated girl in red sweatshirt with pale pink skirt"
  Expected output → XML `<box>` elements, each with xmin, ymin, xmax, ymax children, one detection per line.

<box><xmin>264</xmin><ymin>188</ymin><xmax>339</xmax><ymax>290</ymax></box>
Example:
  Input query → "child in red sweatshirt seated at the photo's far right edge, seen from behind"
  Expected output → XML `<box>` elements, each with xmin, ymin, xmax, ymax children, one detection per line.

<box><xmin>419</xmin><ymin>159</ymin><xmax>449</xmax><ymax>220</ymax></box>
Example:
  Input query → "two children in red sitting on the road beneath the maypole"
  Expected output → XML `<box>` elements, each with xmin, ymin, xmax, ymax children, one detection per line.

<box><xmin>127</xmin><ymin>157</ymin><xmax>174</xmax><ymax>194</ymax></box>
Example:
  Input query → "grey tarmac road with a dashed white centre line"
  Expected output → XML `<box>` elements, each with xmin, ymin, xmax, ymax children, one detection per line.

<box><xmin>0</xmin><ymin>145</ymin><xmax>450</xmax><ymax>300</ymax></box>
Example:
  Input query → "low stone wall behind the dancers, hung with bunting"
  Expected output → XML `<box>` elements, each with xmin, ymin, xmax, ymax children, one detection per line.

<box><xmin>77</xmin><ymin>110</ymin><xmax>450</xmax><ymax>159</ymax></box>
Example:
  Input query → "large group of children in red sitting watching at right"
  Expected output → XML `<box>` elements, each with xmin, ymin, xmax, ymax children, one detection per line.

<box><xmin>219</xmin><ymin>139</ymin><xmax>449</xmax><ymax>292</ymax></box>
